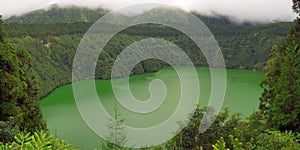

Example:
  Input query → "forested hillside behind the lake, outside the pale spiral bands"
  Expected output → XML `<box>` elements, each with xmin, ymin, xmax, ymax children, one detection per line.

<box><xmin>4</xmin><ymin>7</ymin><xmax>292</xmax><ymax>96</ymax></box>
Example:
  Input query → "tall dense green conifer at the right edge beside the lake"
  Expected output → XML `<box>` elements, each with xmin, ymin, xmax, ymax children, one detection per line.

<box><xmin>260</xmin><ymin>0</ymin><xmax>300</xmax><ymax>131</ymax></box>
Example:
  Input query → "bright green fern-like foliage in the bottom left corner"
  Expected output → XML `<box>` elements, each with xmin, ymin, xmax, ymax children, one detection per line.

<box><xmin>0</xmin><ymin>131</ymin><xmax>74</xmax><ymax>150</ymax></box>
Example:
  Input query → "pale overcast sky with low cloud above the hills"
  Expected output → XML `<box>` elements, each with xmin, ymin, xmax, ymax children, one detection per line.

<box><xmin>0</xmin><ymin>0</ymin><xmax>295</xmax><ymax>22</ymax></box>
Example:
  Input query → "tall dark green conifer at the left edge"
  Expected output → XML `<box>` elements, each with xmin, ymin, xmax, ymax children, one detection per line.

<box><xmin>0</xmin><ymin>16</ymin><xmax>45</xmax><ymax>142</ymax></box>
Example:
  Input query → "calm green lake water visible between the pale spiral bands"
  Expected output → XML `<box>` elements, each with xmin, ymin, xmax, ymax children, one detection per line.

<box><xmin>40</xmin><ymin>68</ymin><xmax>263</xmax><ymax>149</ymax></box>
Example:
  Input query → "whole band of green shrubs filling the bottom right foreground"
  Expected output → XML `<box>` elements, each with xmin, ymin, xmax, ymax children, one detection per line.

<box><xmin>166</xmin><ymin>104</ymin><xmax>300</xmax><ymax>150</ymax></box>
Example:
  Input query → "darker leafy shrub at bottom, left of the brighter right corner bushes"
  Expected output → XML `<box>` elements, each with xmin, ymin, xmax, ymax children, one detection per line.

<box><xmin>166</xmin><ymin>106</ymin><xmax>244</xmax><ymax>149</ymax></box>
